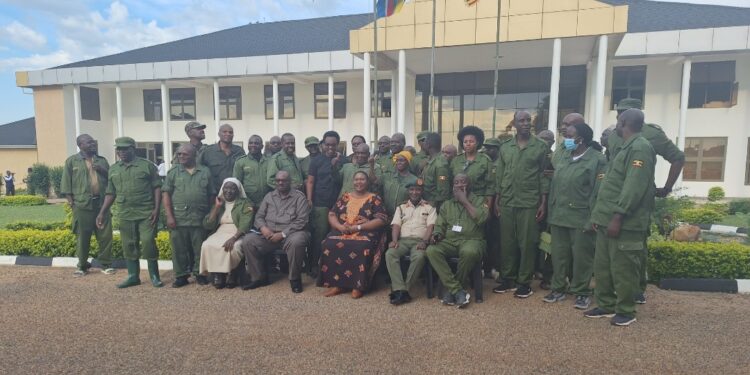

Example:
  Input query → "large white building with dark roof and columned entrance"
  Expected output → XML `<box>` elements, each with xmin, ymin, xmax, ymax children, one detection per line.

<box><xmin>10</xmin><ymin>0</ymin><xmax>750</xmax><ymax>197</ymax></box>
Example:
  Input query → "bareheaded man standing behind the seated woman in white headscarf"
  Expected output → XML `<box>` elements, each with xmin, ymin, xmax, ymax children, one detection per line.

<box><xmin>198</xmin><ymin>124</ymin><xmax>245</xmax><ymax>191</ymax></box>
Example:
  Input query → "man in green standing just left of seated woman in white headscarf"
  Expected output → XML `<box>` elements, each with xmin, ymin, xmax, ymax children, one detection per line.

<box><xmin>162</xmin><ymin>144</ymin><xmax>216</xmax><ymax>288</ymax></box>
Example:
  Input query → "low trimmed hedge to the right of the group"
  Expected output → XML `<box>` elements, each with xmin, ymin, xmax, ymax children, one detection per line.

<box><xmin>648</xmin><ymin>241</ymin><xmax>750</xmax><ymax>282</ymax></box>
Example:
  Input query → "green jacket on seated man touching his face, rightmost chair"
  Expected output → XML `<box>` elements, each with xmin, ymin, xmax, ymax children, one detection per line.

<box><xmin>433</xmin><ymin>192</ymin><xmax>490</xmax><ymax>241</ymax></box>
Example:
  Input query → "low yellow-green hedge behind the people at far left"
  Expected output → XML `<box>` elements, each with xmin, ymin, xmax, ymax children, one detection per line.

<box><xmin>0</xmin><ymin>229</ymin><xmax>172</xmax><ymax>260</ymax></box>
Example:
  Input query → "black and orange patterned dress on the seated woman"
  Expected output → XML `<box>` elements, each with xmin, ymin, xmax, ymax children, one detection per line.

<box><xmin>319</xmin><ymin>193</ymin><xmax>388</xmax><ymax>292</ymax></box>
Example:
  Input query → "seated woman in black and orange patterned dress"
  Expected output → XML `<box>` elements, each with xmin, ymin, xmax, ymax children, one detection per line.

<box><xmin>319</xmin><ymin>171</ymin><xmax>388</xmax><ymax>298</ymax></box>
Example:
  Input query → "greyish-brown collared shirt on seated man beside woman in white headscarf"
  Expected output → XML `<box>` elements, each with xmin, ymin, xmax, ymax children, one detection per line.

<box><xmin>255</xmin><ymin>189</ymin><xmax>310</xmax><ymax>236</ymax></box>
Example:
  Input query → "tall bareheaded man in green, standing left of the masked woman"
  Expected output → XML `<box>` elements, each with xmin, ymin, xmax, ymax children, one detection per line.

<box><xmin>492</xmin><ymin>111</ymin><xmax>550</xmax><ymax>298</ymax></box>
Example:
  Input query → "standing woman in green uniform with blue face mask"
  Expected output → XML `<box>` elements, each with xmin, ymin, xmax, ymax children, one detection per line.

<box><xmin>544</xmin><ymin>123</ymin><xmax>607</xmax><ymax>310</ymax></box>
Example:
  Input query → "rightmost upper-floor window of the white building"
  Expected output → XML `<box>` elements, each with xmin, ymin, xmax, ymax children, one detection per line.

<box><xmin>688</xmin><ymin>61</ymin><xmax>739</xmax><ymax>108</ymax></box>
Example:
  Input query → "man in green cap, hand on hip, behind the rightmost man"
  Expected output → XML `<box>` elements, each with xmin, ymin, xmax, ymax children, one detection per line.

<box><xmin>607</xmin><ymin>98</ymin><xmax>685</xmax><ymax>304</ymax></box>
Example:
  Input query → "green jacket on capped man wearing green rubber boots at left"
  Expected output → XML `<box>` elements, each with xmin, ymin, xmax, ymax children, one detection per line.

<box><xmin>107</xmin><ymin>157</ymin><xmax>161</xmax><ymax>220</ymax></box>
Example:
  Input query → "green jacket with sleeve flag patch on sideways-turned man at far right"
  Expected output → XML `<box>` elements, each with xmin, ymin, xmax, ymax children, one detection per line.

<box><xmin>591</xmin><ymin>135</ymin><xmax>656</xmax><ymax>231</ymax></box>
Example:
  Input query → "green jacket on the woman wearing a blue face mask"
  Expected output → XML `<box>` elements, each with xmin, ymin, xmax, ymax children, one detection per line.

<box><xmin>547</xmin><ymin>148</ymin><xmax>607</xmax><ymax>229</ymax></box>
